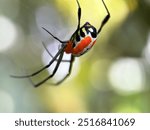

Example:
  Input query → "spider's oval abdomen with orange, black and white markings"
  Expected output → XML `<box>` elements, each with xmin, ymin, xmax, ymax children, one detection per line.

<box><xmin>65</xmin><ymin>22</ymin><xmax>97</xmax><ymax>56</ymax></box>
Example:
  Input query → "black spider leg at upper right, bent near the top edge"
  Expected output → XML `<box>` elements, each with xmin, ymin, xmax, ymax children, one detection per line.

<box><xmin>97</xmin><ymin>0</ymin><xmax>110</xmax><ymax>34</ymax></box>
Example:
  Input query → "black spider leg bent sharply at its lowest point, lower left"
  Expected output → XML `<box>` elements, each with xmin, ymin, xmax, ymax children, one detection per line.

<box><xmin>29</xmin><ymin>52</ymin><xmax>64</xmax><ymax>87</ymax></box>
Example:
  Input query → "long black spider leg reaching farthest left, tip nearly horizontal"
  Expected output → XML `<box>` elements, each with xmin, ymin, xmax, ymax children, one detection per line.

<box><xmin>10</xmin><ymin>44</ymin><xmax>66</xmax><ymax>78</ymax></box>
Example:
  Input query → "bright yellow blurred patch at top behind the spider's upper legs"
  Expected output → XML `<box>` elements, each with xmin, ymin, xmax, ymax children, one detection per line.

<box><xmin>56</xmin><ymin>0</ymin><xmax>129</xmax><ymax>28</ymax></box>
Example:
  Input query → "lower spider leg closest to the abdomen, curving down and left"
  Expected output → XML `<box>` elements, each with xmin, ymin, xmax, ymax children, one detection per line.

<box><xmin>51</xmin><ymin>55</ymin><xmax>75</xmax><ymax>85</ymax></box>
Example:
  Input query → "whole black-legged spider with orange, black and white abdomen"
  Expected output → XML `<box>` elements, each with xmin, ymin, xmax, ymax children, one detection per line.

<box><xmin>11</xmin><ymin>0</ymin><xmax>110</xmax><ymax>87</ymax></box>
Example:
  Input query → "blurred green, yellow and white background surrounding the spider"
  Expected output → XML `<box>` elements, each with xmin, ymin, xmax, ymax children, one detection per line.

<box><xmin>0</xmin><ymin>0</ymin><xmax>150</xmax><ymax>112</ymax></box>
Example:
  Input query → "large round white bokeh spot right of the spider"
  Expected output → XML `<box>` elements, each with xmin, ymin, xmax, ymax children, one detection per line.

<box><xmin>109</xmin><ymin>58</ymin><xmax>144</xmax><ymax>94</ymax></box>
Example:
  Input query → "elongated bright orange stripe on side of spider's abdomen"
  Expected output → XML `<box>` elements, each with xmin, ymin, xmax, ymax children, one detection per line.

<box><xmin>72</xmin><ymin>36</ymin><xmax>92</xmax><ymax>54</ymax></box>
